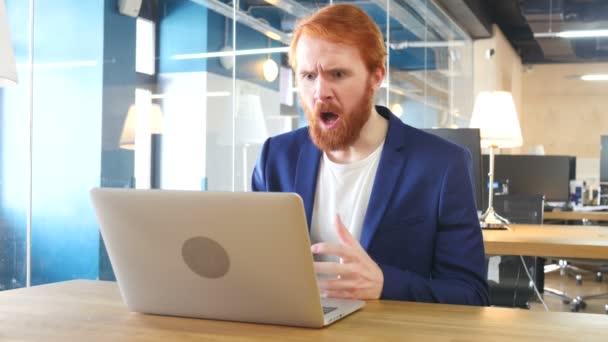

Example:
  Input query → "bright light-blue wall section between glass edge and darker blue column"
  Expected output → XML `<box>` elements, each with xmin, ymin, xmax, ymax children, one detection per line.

<box><xmin>32</xmin><ymin>0</ymin><xmax>104</xmax><ymax>285</ymax></box>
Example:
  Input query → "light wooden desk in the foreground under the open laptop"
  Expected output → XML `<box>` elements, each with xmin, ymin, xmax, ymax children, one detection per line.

<box><xmin>0</xmin><ymin>280</ymin><xmax>608</xmax><ymax>342</ymax></box>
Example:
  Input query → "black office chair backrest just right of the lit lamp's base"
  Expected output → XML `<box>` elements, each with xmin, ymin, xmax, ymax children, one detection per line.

<box><xmin>494</xmin><ymin>195</ymin><xmax>545</xmax><ymax>224</ymax></box>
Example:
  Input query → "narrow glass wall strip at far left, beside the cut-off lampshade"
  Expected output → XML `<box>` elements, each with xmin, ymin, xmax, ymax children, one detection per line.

<box><xmin>0</xmin><ymin>0</ymin><xmax>31</xmax><ymax>291</ymax></box>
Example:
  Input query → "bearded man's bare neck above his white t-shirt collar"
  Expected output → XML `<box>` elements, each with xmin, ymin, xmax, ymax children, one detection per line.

<box><xmin>325</xmin><ymin>107</ymin><xmax>388</xmax><ymax>164</ymax></box>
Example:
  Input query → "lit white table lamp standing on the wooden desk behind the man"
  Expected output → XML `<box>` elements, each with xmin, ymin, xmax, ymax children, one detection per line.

<box><xmin>470</xmin><ymin>91</ymin><xmax>523</xmax><ymax>229</ymax></box>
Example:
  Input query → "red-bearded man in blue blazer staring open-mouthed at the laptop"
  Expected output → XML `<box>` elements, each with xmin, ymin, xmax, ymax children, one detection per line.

<box><xmin>253</xmin><ymin>4</ymin><xmax>488</xmax><ymax>305</ymax></box>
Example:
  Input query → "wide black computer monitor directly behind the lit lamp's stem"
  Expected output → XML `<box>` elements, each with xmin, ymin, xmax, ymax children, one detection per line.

<box><xmin>482</xmin><ymin>154</ymin><xmax>576</xmax><ymax>202</ymax></box>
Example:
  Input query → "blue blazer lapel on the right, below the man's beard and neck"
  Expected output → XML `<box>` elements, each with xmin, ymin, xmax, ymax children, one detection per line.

<box><xmin>360</xmin><ymin>112</ymin><xmax>407</xmax><ymax>250</ymax></box>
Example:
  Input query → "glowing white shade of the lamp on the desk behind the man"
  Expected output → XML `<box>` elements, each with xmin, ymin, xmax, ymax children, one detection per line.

<box><xmin>470</xmin><ymin>91</ymin><xmax>523</xmax><ymax>148</ymax></box>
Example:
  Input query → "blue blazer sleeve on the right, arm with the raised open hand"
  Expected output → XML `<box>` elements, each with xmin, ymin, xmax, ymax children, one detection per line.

<box><xmin>379</xmin><ymin>151</ymin><xmax>489</xmax><ymax>305</ymax></box>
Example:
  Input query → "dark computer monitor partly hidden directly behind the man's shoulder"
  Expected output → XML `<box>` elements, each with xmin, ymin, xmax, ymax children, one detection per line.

<box><xmin>423</xmin><ymin>128</ymin><xmax>485</xmax><ymax>210</ymax></box>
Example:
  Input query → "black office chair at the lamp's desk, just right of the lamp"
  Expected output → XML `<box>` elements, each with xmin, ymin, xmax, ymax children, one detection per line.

<box><xmin>489</xmin><ymin>195</ymin><xmax>545</xmax><ymax>309</ymax></box>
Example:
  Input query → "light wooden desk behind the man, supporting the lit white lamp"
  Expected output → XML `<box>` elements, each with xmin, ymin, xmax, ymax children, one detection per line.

<box><xmin>483</xmin><ymin>224</ymin><xmax>608</xmax><ymax>260</ymax></box>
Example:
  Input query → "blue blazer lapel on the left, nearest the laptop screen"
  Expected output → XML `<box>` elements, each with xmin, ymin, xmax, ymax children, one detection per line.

<box><xmin>295</xmin><ymin>139</ymin><xmax>321</xmax><ymax>230</ymax></box>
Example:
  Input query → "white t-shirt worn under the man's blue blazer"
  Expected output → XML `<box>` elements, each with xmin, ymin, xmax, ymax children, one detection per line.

<box><xmin>310</xmin><ymin>143</ymin><xmax>384</xmax><ymax>261</ymax></box>
